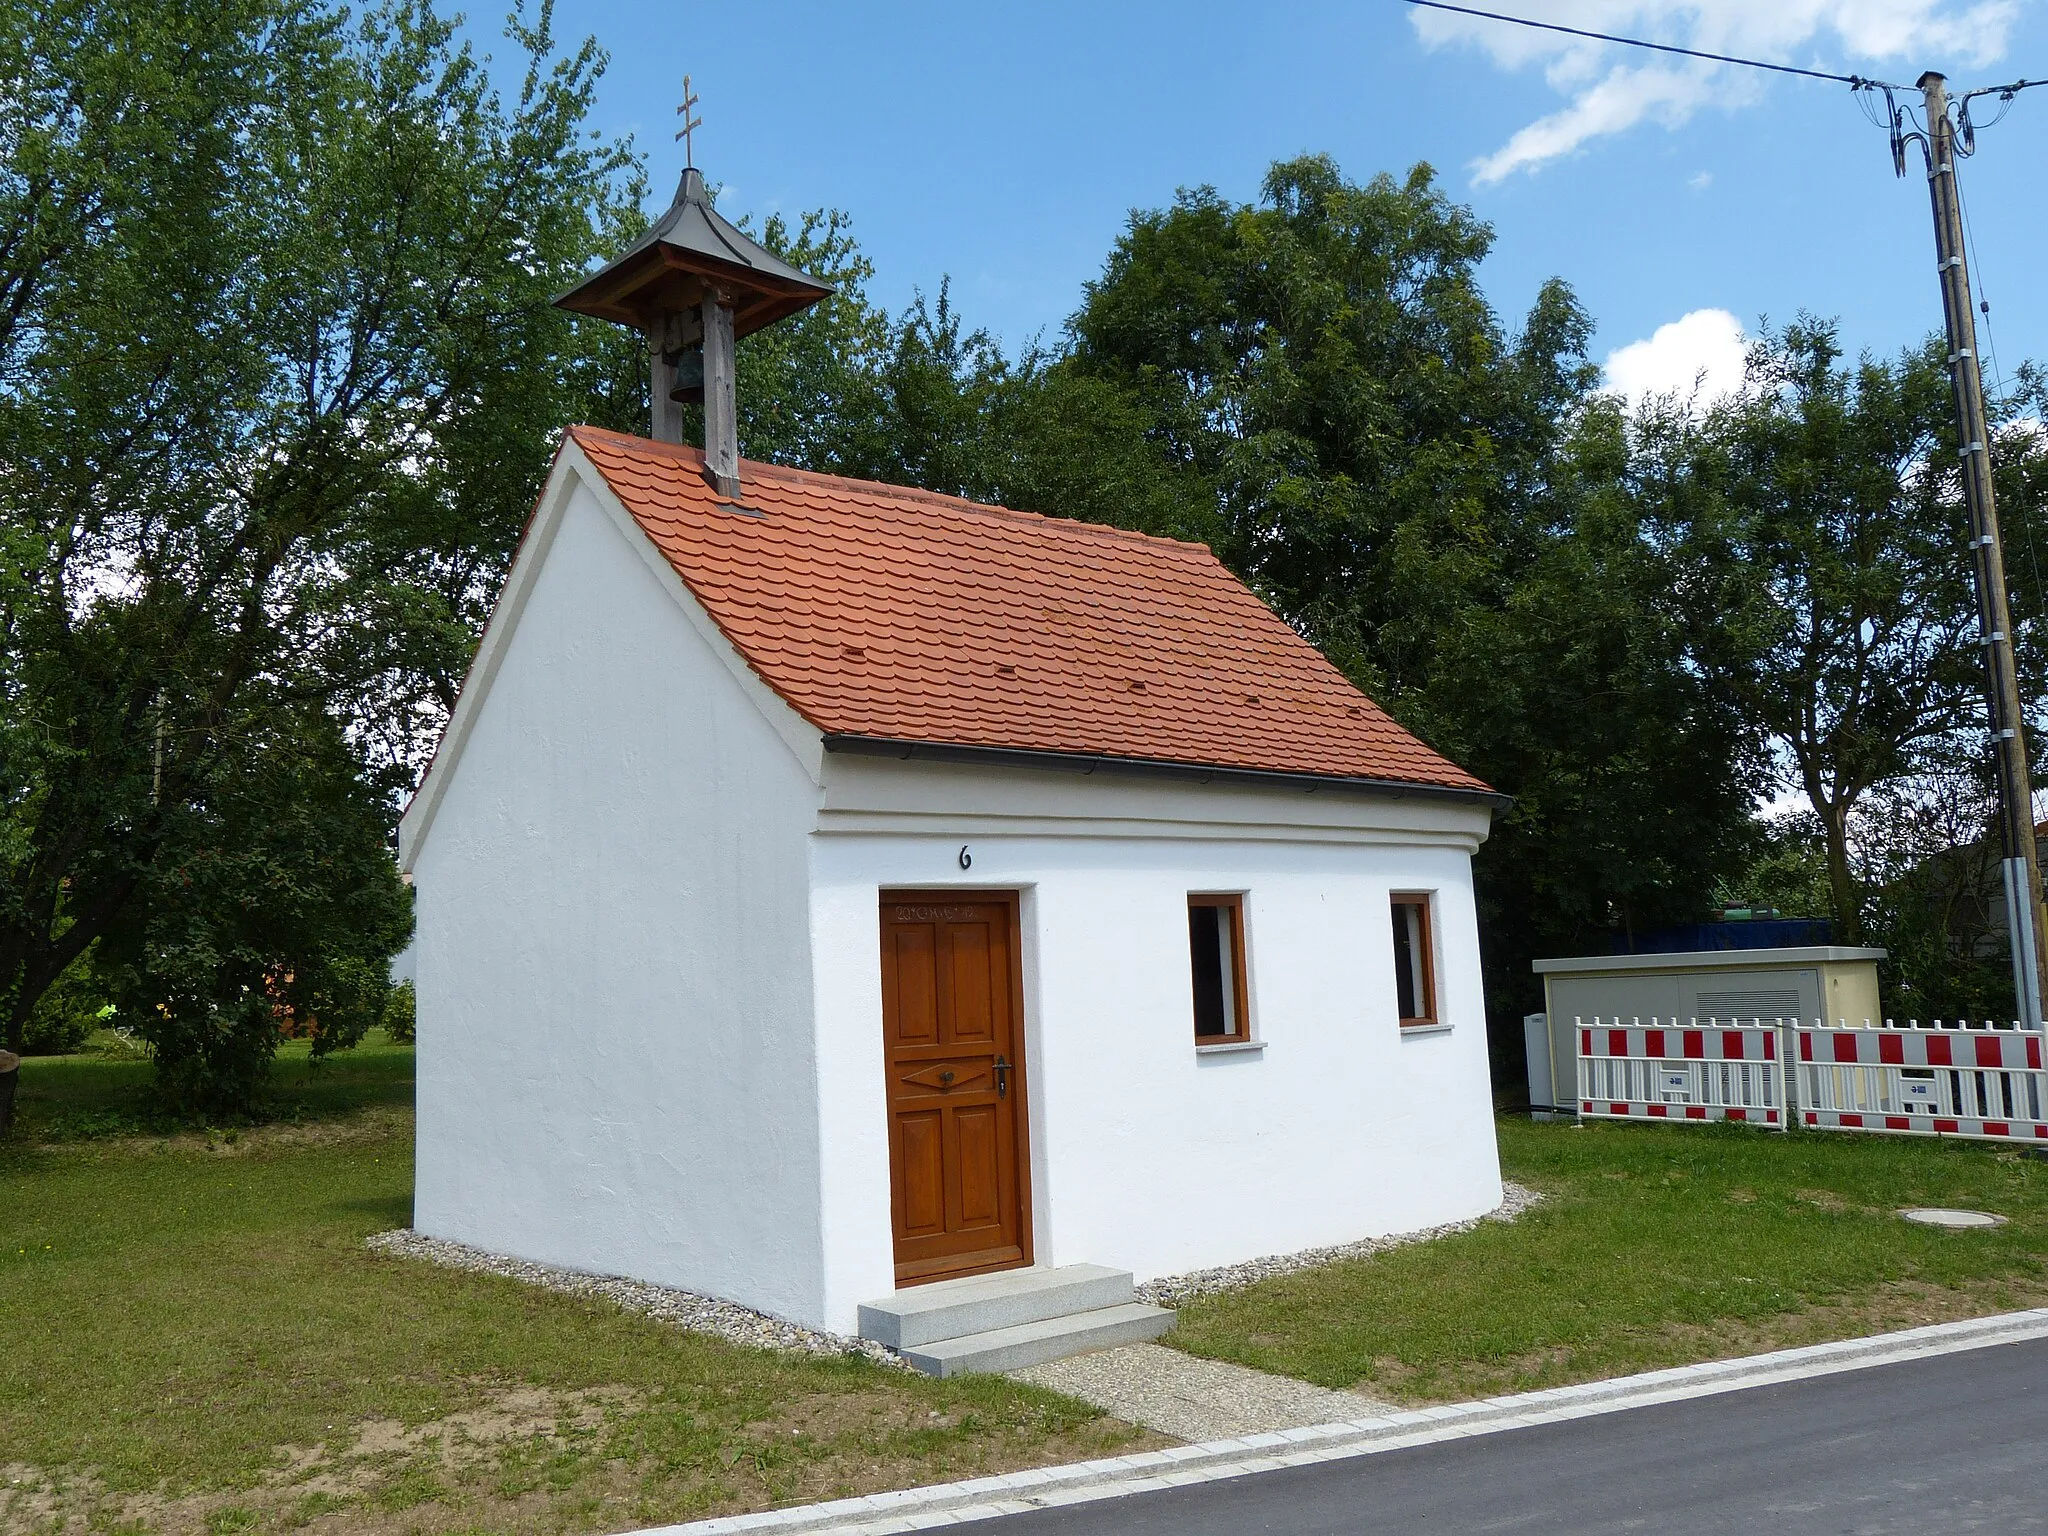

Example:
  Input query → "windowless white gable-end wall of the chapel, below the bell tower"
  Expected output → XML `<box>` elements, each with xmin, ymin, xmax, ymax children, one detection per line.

<box><xmin>410</xmin><ymin>475</ymin><xmax>827</xmax><ymax>1321</ymax></box>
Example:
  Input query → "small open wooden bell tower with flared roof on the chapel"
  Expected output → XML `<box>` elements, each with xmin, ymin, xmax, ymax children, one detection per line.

<box><xmin>555</xmin><ymin>154</ymin><xmax>831</xmax><ymax>500</ymax></box>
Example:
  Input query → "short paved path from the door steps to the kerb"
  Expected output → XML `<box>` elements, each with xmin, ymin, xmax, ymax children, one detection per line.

<box><xmin>1010</xmin><ymin>1343</ymin><xmax>1395</xmax><ymax>1444</ymax></box>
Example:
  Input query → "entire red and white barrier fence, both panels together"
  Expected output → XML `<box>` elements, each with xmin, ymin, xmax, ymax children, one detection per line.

<box><xmin>1575</xmin><ymin>1018</ymin><xmax>2048</xmax><ymax>1143</ymax></box>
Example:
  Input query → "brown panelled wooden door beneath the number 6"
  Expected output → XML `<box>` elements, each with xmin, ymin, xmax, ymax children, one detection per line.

<box><xmin>883</xmin><ymin>891</ymin><xmax>1030</xmax><ymax>1284</ymax></box>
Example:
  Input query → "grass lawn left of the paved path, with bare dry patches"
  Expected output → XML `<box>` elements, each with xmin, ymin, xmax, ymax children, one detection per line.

<box><xmin>0</xmin><ymin>1044</ymin><xmax>1137</xmax><ymax>1536</ymax></box>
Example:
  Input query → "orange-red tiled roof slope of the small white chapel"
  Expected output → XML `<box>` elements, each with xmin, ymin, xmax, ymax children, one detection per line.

<box><xmin>569</xmin><ymin>426</ymin><xmax>1485</xmax><ymax>791</ymax></box>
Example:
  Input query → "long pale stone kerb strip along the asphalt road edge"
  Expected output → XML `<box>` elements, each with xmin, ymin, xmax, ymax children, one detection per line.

<box><xmin>614</xmin><ymin>1307</ymin><xmax>2048</xmax><ymax>1536</ymax></box>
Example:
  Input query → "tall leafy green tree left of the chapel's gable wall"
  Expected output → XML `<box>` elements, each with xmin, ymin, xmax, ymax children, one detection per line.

<box><xmin>0</xmin><ymin>0</ymin><xmax>637</xmax><ymax>1106</ymax></box>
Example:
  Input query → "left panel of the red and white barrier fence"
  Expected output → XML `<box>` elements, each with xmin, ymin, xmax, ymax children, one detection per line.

<box><xmin>1579</xmin><ymin>1018</ymin><xmax>1788</xmax><ymax>1130</ymax></box>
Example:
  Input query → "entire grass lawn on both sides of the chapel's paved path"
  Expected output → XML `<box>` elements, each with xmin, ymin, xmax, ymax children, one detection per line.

<box><xmin>16</xmin><ymin>1042</ymin><xmax>2048</xmax><ymax>1536</ymax></box>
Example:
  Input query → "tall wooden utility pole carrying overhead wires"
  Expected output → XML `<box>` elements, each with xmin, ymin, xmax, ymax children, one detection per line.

<box><xmin>1917</xmin><ymin>72</ymin><xmax>2048</xmax><ymax>1030</ymax></box>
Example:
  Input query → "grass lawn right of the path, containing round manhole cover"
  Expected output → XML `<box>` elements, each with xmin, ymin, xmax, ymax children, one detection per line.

<box><xmin>1167</xmin><ymin>1120</ymin><xmax>2048</xmax><ymax>1401</ymax></box>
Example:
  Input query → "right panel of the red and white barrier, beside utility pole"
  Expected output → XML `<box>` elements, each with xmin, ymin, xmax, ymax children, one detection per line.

<box><xmin>1792</xmin><ymin>1024</ymin><xmax>2048</xmax><ymax>1141</ymax></box>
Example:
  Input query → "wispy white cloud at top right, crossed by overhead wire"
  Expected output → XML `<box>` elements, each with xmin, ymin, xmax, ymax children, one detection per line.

<box><xmin>1413</xmin><ymin>0</ymin><xmax>2019</xmax><ymax>182</ymax></box>
